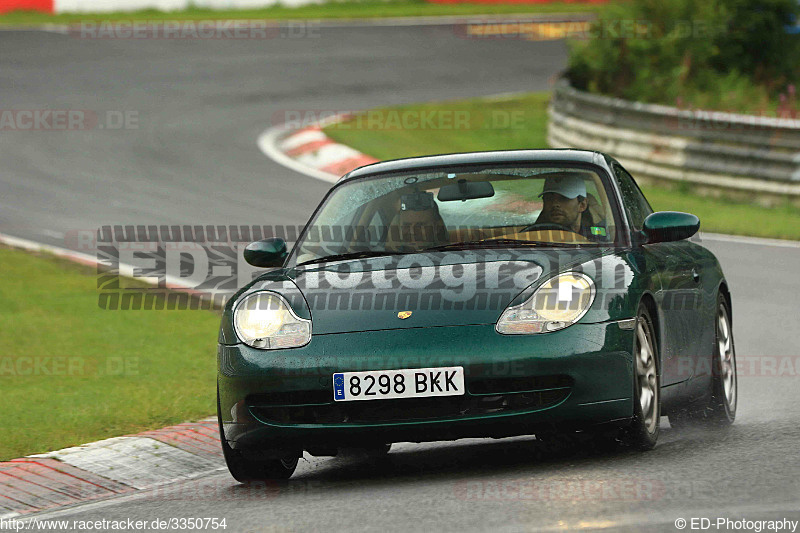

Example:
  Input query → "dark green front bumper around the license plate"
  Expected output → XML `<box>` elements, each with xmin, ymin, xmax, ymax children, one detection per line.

<box><xmin>218</xmin><ymin>322</ymin><xmax>634</xmax><ymax>451</ymax></box>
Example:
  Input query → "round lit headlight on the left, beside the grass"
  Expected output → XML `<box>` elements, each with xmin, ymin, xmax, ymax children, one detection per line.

<box><xmin>233</xmin><ymin>291</ymin><xmax>311</xmax><ymax>350</ymax></box>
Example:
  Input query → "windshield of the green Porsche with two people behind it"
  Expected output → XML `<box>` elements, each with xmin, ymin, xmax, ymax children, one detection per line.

<box><xmin>292</xmin><ymin>164</ymin><xmax>617</xmax><ymax>264</ymax></box>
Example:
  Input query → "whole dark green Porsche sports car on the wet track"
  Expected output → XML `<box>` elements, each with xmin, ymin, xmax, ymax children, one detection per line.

<box><xmin>217</xmin><ymin>150</ymin><xmax>737</xmax><ymax>482</ymax></box>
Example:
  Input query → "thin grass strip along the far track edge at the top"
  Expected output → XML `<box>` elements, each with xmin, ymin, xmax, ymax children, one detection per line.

<box><xmin>0</xmin><ymin>0</ymin><xmax>599</xmax><ymax>25</ymax></box>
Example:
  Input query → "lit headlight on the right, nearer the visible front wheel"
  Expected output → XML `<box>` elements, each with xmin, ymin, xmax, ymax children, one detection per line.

<box><xmin>495</xmin><ymin>272</ymin><xmax>596</xmax><ymax>335</ymax></box>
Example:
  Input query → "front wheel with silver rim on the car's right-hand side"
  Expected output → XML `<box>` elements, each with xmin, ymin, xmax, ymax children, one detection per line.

<box><xmin>623</xmin><ymin>304</ymin><xmax>661</xmax><ymax>450</ymax></box>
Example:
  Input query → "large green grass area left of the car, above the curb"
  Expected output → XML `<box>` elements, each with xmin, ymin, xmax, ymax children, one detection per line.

<box><xmin>0</xmin><ymin>248</ymin><xmax>219</xmax><ymax>460</ymax></box>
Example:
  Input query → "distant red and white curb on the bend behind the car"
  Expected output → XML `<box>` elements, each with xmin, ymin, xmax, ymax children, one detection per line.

<box><xmin>258</xmin><ymin>115</ymin><xmax>378</xmax><ymax>183</ymax></box>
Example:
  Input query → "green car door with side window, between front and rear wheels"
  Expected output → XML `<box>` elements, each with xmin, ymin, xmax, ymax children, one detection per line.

<box><xmin>613</xmin><ymin>164</ymin><xmax>702</xmax><ymax>386</ymax></box>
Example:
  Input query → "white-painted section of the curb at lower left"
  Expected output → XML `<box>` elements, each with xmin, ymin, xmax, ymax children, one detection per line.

<box><xmin>31</xmin><ymin>437</ymin><xmax>219</xmax><ymax>490</ymax></box>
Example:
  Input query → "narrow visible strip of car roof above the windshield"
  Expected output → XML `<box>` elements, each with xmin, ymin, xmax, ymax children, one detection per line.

<box><xmin>337</xmin><ymin>148</ymin><xmax>606</xmax><ymax>183</ymax></box>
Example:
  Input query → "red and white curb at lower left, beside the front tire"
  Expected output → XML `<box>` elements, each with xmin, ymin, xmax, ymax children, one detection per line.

<box><xmin>0</xmin><ymin>418</ymin><xmax>225</xmax><ymax>519</ymax></box>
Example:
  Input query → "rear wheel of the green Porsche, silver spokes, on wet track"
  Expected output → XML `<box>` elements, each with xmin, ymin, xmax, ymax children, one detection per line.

<box><xmin>669</xmin><ymin>294</ymin><xmax>739</xmax><ymax>429</ymax></box>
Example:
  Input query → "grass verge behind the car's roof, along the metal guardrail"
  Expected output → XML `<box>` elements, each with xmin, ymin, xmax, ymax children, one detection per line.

<box><xmin>325</xmin><ymin>93</ymin><xmax>800</xmax><ymax>240</ymax></box>
